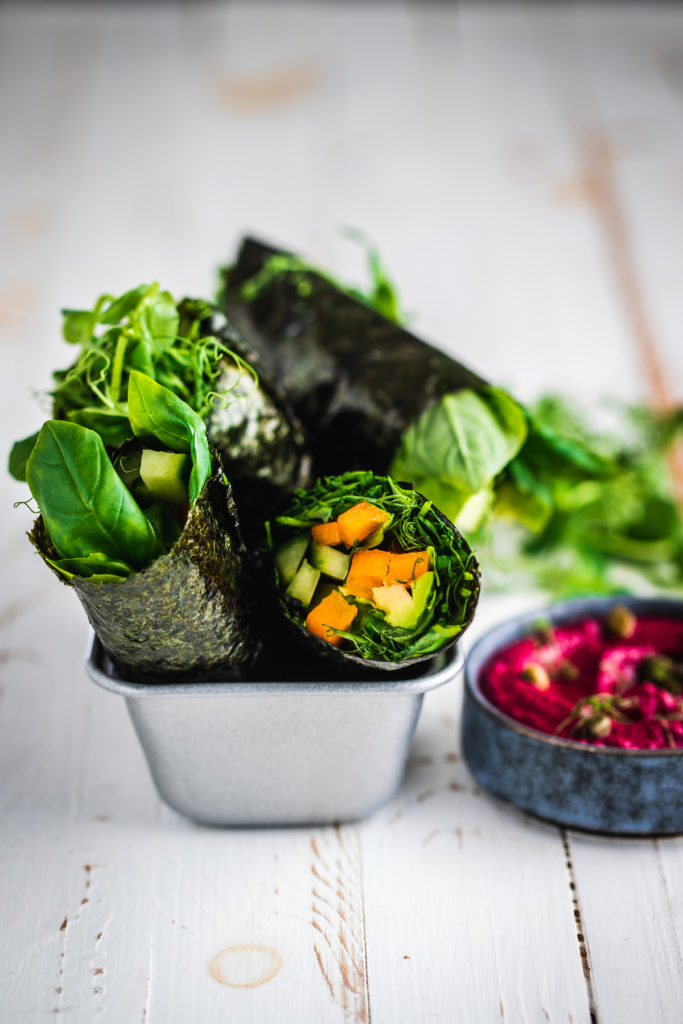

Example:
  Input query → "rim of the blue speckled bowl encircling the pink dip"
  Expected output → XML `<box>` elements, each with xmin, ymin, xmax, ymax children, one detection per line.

<box><xmin>464</xmin><ymin>594</ymin><xmax>683</xmax><ymax>760</ymax></box>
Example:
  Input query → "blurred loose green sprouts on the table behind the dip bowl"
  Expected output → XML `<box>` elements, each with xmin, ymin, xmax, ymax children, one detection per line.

<box><xmin>477</xmin><ymin>396</ymin><xmax>683</xmax><ymax>596</ymax></box>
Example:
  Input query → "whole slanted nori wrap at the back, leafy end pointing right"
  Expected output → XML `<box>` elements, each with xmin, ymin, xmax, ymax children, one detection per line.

<box><xmin>218</xmin><ymin>239</ymin><xmax>618</xmax><ymax>550</ymax></box>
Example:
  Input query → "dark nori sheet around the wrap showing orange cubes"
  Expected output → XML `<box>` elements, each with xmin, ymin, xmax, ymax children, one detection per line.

<box><xmin>268</xmin><ymin>473</ymin><xmax>481</xmax><ymax>681</ymax></box>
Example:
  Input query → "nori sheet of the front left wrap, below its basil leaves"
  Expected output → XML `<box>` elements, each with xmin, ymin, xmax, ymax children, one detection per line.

<box><xmin>29</xmin><ymin>470</ymin><xmax>260</xmax><ymax>683</ymax></box>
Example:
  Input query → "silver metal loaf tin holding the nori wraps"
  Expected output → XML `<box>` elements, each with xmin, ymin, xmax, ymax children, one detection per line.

<box><xmin>86</xmin><ymin>638</ymin><xmax>462</xmax><ymax>825</ymax></box>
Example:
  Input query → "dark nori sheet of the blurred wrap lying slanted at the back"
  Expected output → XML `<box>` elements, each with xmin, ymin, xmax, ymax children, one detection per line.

<box><xmin>219</xmin><ymin>239</ymin><xmax>486</xmax><ymax>476</ymax></box>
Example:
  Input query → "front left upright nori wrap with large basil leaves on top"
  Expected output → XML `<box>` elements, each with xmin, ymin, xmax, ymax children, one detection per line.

<box><xmin>27</xmin><ymin>372</ymin><xmax>260</xmax><ymax>682</ymax></box>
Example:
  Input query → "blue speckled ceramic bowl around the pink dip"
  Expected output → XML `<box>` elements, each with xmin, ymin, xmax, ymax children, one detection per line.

<box><xmin>462</xmin><ymin>596</ymin><xmax>683</xmax><ymax>836</ymax></box>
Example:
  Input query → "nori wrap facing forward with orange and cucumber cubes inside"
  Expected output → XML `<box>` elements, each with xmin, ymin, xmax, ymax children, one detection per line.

<box><xmin>267</xmin><ymin>471</ymin><xmax>479</xmax><ymax>679</ymax></box>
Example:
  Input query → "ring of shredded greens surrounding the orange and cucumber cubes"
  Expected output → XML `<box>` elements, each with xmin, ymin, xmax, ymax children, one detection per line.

<box><xmin>267</xmin><ymin>471</ymin><xmax>479</xmax><ymax>662</ymax></box>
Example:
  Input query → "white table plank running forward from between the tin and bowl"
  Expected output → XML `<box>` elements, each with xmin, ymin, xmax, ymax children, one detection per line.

<box><xmin>362</xmin><ymin>599</ymin><xmax>590</xmax><ymax>1024</ymax></box>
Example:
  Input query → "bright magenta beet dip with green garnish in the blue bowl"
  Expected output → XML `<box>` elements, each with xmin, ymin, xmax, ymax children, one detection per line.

<box><xmin>480</xmin><ymin>605</ymin><xmax>683</xmax><ymax>750</ymax></box>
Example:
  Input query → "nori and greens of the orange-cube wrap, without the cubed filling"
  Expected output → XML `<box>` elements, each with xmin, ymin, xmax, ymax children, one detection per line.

<box><xmin>269</xmin><ymin>471</ymin><xmax>480</xmax><ymax>680</ymax></box>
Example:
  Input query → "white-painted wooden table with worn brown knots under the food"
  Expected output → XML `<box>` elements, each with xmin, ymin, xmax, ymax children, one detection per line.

<box><xmin>0</xmin><ymin>2</ymin><xmax>683</xmax><ymax>1024</ymax></box>
